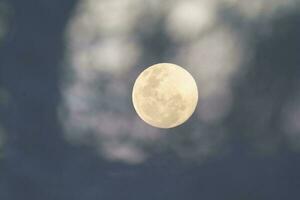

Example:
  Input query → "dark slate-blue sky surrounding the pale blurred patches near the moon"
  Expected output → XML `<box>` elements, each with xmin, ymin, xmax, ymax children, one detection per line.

<box><xmin>0</xmin><ymin>0</ymin><xmax>300</xmax><ymax>200</ymax></box>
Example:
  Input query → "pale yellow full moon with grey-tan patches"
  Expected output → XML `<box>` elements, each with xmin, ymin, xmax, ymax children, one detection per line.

<box><xmin>132</xmin><ymin>63</ymin><xmax>198</xmax><ymax>128</ymax></box>
